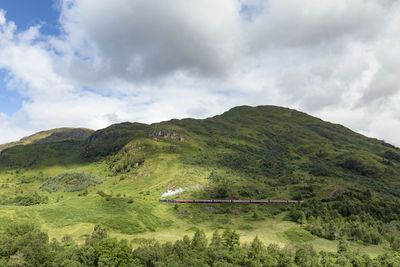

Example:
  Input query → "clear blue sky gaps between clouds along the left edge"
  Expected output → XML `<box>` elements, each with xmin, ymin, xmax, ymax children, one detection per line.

<box><xmin>0</xmin><ymin>0</ymin><xmax>60</xmax><ymax>115</ymax></box>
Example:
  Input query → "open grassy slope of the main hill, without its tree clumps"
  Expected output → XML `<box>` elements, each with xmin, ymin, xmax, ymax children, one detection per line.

<box><xmin>0</xmin><ymin>106</ymin><xmax>400</xmax><ymax>255</ymax></box>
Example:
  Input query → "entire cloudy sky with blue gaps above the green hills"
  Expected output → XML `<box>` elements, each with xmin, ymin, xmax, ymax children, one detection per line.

<box><xmin>0</xmin><ymin>0</ymin><xmax>400</xmax><ymax>146</ymax></box>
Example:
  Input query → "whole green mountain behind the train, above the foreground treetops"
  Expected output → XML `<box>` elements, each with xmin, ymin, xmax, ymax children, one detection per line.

<box><xmin>0</xmin><ymin>106</ymin><xmax>400</xmax><ymax>256</ymax></box>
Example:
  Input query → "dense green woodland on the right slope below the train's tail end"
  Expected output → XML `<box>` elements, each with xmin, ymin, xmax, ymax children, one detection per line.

<box><xmin>290</xmin><ymin>191</ymin><xmax>400</xmax><ymax>249</ymax></box>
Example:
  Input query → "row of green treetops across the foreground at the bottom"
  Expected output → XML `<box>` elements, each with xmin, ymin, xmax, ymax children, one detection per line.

<box><xmin>0</xmin><ymin>223</ymin><xmax>400</xmax><ymax>267</ymax></box>
